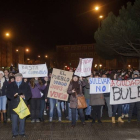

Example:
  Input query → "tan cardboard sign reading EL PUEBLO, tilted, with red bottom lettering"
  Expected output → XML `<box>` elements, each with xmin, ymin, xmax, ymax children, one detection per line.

<box><xmin>48</xmin><ymin>69</ymin><xmax>73</xmax><ymax>101</ymax></box>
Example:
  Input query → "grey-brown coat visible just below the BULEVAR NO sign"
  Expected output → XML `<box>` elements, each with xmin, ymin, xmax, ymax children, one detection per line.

<box><xmin>90</xmin><ymin>94</ymin><xmax>105</xmax><ymax>106</ymax></box>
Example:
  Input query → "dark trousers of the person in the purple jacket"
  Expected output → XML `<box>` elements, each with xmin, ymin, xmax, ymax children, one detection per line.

<box><xmin>31</xmin><ymin>98</ymin><xmax>41</xmax><ymax>120</ymax></box>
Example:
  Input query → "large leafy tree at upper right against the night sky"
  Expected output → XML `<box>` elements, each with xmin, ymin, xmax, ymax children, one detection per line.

<box><xmin>94</xmin><ymin>0</ymin><xmax>140</xmax><ymax>58</ymax></box>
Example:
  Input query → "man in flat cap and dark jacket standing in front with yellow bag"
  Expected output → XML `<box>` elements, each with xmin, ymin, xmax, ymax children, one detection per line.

<box><xmin>7</xmin><ymin>73</ymin><xmax>31</xmax><ymax>138</ymax></box>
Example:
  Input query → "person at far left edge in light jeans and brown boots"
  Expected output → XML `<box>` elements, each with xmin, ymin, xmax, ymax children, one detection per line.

<box><xmin>0</xmin><ymin>71</ymin><xmax>8</xmax><ymax>123</ymax></box>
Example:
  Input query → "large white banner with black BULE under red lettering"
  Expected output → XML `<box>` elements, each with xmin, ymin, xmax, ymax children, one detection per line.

<box><xmin>110</xmin><ymin>79</ymin><xmax>140</xmax><ymax>105</ymax></box>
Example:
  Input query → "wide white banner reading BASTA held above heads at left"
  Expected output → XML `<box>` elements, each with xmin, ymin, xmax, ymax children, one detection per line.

<box><xmin>18</xmin><ymin>64</ymin><xmax>48</xmax><ymax>78</ymax></box>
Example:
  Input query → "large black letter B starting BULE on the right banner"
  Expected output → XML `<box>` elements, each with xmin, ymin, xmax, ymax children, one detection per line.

<box><xmin>112</xmin><ymin>87</ymin><xmax>122</xmax><ymax>101</ymax></box>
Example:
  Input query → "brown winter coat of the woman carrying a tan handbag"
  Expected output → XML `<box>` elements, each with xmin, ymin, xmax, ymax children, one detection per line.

<box><xmin>67</xmin><ymin>81</ymin><xmax>85</xmax><ymax>108</ymax></box>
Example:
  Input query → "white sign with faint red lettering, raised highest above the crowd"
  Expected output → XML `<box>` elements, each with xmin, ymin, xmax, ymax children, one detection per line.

<box><xmin>74</xmin><ymin>58</ymin><xmax>93</xmax><ymax>77</ymax></box>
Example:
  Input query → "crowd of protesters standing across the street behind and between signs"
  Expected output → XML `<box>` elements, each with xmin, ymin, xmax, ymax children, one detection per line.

<box><xmin>0</xmin><ymin>69</ymin><xmax>140</xmax><ymax>138</ymax></box>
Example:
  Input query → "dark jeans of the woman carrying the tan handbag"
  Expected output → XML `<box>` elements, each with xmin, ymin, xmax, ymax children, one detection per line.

<box><xmin>71</xmin><ymin>108</ymin><xmax>85</xmax><ymax>125</ymax></box>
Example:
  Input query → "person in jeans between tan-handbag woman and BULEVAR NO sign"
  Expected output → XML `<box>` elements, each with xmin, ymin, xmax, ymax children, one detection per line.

<box><xmin>84</xmin><ymin>75</ymin><xmax>92</xmax><ymax>120</ymax></box>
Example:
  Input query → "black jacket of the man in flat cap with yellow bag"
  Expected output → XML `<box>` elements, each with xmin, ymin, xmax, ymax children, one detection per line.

<box><xmin>7</xmin><ymin>82</ymin><xmax>32</xmax><ymax>114</ymax></box>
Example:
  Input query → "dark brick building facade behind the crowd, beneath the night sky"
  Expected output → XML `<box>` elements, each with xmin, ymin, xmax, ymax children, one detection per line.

<box><xmin>56</xmin><ymin>44</ymin><xmax>139</xmax><ymax>69</ymax></box>
